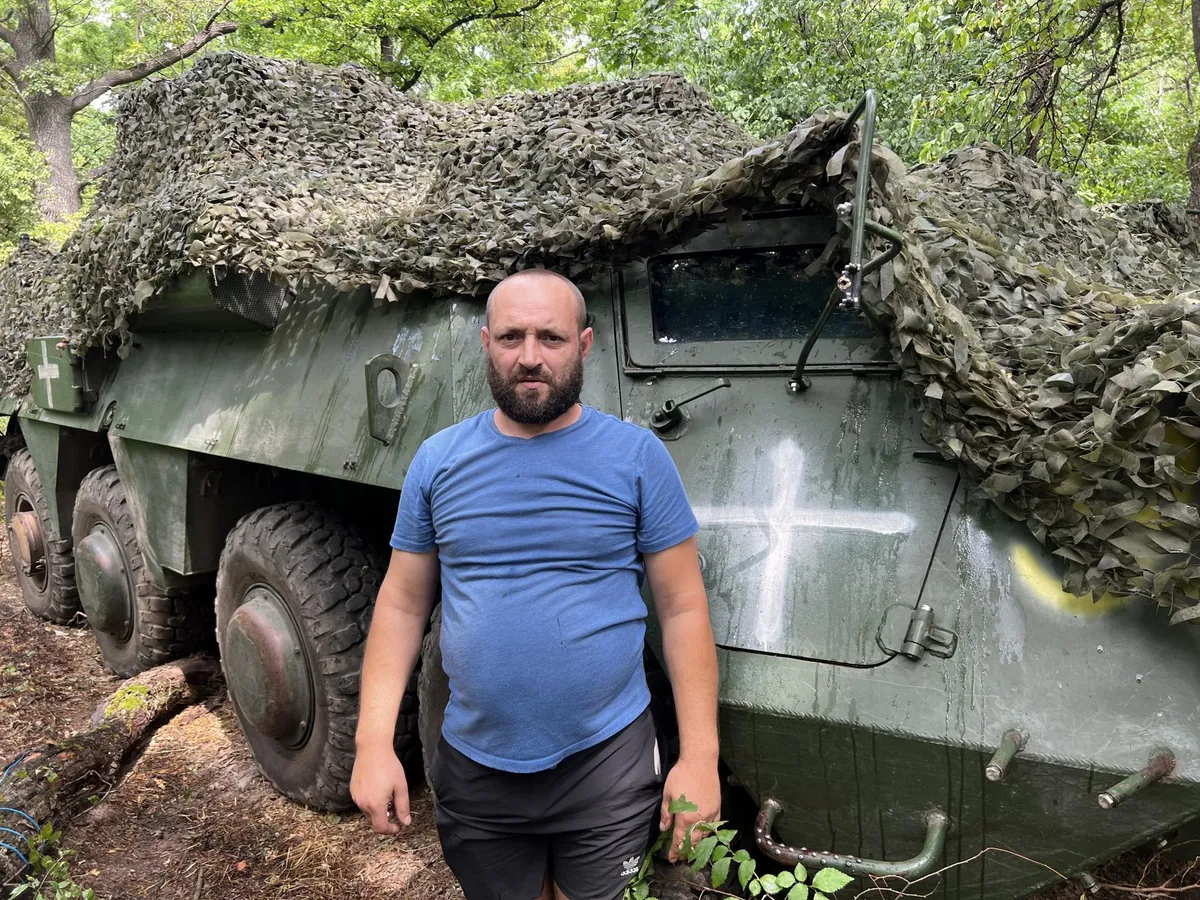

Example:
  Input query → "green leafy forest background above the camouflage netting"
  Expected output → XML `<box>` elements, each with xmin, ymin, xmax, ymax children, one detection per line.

<box><xmin>0</xmin><ymin>0</ymin><xmax>1200</xmax><ymax>258</ymax></box>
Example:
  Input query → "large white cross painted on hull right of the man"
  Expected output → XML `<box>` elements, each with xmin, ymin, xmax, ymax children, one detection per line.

<box><xmin>692</xmin><ymin>438</ymin><xmax>916</xmax><ymax>647</ymax></box>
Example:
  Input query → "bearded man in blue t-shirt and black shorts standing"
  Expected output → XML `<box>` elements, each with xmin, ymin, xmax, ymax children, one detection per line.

<box><xmin>350</xmin><ymin>270</ymin><xmax>720</xmax><ymax>900</ymax></box>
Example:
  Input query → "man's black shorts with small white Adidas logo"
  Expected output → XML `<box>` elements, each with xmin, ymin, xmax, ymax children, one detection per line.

<box><xmin>430</xmin><ymin>709</ymin><xmax>665</xmax><ymax>900</ymax></box>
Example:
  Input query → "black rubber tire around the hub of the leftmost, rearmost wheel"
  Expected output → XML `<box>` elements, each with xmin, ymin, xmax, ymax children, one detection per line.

<box><xmin>4</xmin><ymin>448</ymin><xmax>82</xmax><ymax>625</ymax></box>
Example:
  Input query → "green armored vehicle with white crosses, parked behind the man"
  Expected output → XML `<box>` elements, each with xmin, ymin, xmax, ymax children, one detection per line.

<box><xmin>2</xmin><ymin>58</ymin><xmax>1200</xmax><ymax>900</ymax></box>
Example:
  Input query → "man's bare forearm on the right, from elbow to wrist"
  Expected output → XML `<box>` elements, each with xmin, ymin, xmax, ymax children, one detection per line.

<box><xmin>660</xmin><ymin>608</ymin><xmax>718</xmax><ymax>761</ymax></box>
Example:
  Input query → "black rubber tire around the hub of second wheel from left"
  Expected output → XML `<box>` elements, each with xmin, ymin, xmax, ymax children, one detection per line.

<box><xmin>71</xmin><ymin>466</ymin><xmax>212</xmax><ymax>678</ymax></box>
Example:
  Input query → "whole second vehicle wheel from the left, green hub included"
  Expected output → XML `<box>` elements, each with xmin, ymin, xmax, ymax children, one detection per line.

<box><xmin>71</xmin><ymin>466</ymin><xmax>211</xmax><ymax>678</ymax></box>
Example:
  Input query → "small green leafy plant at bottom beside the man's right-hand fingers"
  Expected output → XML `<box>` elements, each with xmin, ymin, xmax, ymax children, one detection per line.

<box><xmin>624</xmin><ymin>796</ymin><xmax>853</xmax><ymax>900</ymax></box>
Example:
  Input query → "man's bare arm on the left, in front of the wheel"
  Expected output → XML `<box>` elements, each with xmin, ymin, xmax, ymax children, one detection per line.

<box><xmin>350</xmin><ymin>550</ymin><xmax>438</xmax><ymax>834</ymax></box>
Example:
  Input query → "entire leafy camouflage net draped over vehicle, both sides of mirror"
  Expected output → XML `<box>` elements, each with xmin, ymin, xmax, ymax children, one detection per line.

<box><xmin>0</xmin><ymin>54</ymin><xmax>1200</xmax><ymax>616</ymax></box>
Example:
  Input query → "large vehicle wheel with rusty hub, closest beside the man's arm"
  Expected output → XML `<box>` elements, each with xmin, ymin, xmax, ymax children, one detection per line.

<box><xmin>216</xmin><ymin>503</ymin><xmax>418</xmax><ymax>811</ymax></box>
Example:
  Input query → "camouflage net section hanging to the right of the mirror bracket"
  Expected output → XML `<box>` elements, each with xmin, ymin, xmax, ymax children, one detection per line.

<box><xmin>876</xmin><ymin>154</ymin><xmax>1200</xmax><ymax>620</ymax></box>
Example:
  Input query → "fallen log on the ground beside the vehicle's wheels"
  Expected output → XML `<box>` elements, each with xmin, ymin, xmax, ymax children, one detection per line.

<box><xmin>0</xmin><ymin>655</ymin><xmax>221</xmax><ymax>884</ymax></box>
